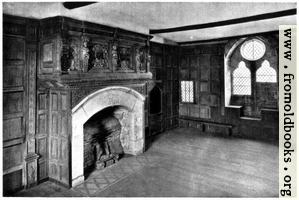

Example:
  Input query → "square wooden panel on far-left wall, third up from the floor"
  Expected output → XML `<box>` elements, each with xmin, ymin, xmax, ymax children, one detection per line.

<box><xmin>3</xmin><ymin>117</ymin><xmax>25</xmax><ymax>142</ymax></box>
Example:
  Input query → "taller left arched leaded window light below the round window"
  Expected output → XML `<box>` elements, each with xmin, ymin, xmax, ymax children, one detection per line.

<box><xmin>233</xmin><ymin>61</ymin><xmax>251</xmax><ymax>95</ymax></box>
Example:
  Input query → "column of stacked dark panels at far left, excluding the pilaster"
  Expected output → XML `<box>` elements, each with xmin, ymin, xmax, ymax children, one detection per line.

<box><xmin>2</xmin><ymin>16</ymin><xmax>27</xmax><ymax>194</ymax></box>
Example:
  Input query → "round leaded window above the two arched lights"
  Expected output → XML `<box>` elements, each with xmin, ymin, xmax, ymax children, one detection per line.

<box><xmin>240</xmin><ymin>39</ymin><xmax>266</xmax><ymax>61</ymax></box>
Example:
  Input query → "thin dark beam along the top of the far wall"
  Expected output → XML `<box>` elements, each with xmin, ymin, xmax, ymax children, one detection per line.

<box><xmin>177</xmin><ymin>30</ymin><xmax>279</xmax><ymax>46</ymax></box>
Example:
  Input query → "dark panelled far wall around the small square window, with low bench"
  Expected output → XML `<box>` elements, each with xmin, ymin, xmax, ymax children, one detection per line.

<box><xmin>179</xmin><ymin>41</ymin><xmax>278</xmax><ymax>142</ymax></box>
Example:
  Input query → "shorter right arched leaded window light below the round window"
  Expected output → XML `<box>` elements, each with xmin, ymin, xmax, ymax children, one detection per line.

<box><xmin>256</xmin><ymin>60</ymin><xmax>277</xmax><ymax>83</ymax></box>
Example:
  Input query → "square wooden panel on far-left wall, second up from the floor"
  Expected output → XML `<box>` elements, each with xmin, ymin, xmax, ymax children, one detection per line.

<box><xmin>3</xmin><ymin>145</ymin><xmax>24</xmax><ymax>170</ymax></box>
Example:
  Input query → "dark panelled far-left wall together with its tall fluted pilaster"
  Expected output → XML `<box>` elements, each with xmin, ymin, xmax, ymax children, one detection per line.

<box><xmin>3</xmin><ymin>16</ymin><xmax>38</xmax><ymax>194</ymax></box>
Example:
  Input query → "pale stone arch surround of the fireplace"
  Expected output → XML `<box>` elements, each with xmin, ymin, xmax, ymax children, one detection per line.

<box><xmin>71</xmin><ymin>86</ymin><xmax>145</xmax><ymax>186</ymax></box>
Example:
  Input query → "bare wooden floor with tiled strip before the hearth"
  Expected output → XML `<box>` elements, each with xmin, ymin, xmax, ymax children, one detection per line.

<box><xmin>15</xmin><ymin>128</ymin><xmax>278</xmax><ymax>197</ymax></box>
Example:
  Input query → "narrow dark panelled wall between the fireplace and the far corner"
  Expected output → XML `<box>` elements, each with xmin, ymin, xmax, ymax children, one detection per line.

<box><xmin>149</xmin><ymin>43</ymin><xmax>179</xmax><ymax>135</ymax></box>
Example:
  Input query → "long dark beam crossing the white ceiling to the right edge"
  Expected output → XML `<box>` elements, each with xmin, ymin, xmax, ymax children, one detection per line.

<box><xmin>149</xmin><ymin>8</ymin><xmax>297</xmax><ymax>34</ymax></box>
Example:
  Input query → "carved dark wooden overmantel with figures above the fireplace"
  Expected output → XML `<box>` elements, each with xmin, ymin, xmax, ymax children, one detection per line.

<box><xmin>39</xmin><ymin>17</ymin><xmax>151</xmax><ymax>77</ymax></box>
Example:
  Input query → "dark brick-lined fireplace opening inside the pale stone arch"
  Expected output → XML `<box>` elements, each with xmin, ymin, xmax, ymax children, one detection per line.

<box><xmin>84</xmin><ymin>106</ymin><xmax>126</xmax><ymax>177</ymax></box>
